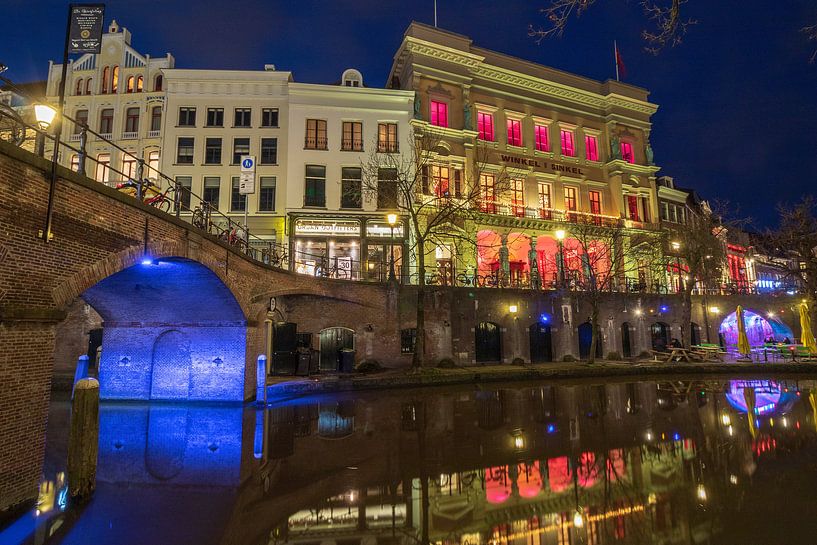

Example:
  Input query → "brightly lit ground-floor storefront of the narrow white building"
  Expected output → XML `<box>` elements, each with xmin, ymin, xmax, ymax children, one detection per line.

<box><xmin>290</xmin><ymin>216</ymin><xmax>404</xmax><ymax>281</ymax></box>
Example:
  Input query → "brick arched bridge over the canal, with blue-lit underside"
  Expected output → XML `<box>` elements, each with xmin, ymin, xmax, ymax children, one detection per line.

<box><xmin>0</xmin><ymin>142</ymin><xmax>399</xmax><ymax>510</ymax></box>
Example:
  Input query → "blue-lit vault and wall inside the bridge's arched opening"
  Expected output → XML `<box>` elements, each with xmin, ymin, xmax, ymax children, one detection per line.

<box><xmin>80</xmin><ymin>257</ymin><xmax>247</xmax><ymax>401</ymax></box>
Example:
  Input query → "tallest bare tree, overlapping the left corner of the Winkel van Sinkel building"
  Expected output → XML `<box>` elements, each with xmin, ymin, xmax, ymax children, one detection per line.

<box><xmin>353</xmin><ymin>129</ymin><xmax>509</xmax><ymax>368</ymax></box>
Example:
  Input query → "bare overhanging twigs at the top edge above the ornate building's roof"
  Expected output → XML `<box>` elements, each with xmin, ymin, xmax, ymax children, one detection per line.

<box><xmin>528</xmin><ymin>0</ymin><xmax>697</xmax><ymax>54</ymax></box>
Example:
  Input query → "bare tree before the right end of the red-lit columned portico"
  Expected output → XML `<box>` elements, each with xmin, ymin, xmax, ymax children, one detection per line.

<box><xmin>558</xmin><ymin>214</ymin><xmax>662</xmax><ymax>363</ymax></box>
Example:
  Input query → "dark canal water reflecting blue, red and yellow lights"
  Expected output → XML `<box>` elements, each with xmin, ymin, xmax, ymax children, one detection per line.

<box><xmin>7</xmin><ymin>379</ymin><xmax>817</xmax><ymax>545</ymax></box>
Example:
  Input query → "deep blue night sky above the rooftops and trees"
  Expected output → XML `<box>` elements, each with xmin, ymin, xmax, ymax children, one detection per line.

<box><xmin>0</xmin><ymin>0</ymin><xmax>817</xmax><ymax>226</ymax></box>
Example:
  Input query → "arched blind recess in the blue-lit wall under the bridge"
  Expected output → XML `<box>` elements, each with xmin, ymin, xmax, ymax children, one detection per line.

<box><xmin>150</xmin><ymin>330</ymin><xmax>193</xmax><ymax>399</ymax></box>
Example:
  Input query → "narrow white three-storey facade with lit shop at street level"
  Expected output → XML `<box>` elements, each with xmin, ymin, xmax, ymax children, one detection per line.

<box><xmin>285</xmin><ymin>69</ymin><xmax>414</xmax><ymax>280</ymax></box>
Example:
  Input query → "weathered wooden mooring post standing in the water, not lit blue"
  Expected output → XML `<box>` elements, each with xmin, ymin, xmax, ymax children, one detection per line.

<box><xmin>68</xmin><ymin>378</ymin><xmax>99</xmax><ymax>502</ymax></box>
